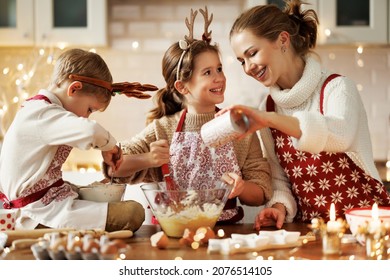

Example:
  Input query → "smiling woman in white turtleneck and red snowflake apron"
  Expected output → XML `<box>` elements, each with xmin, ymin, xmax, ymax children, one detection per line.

<box><xmin>220</xmin><ymin>0</ymin><xmax>390</xmax><ymax>229</ymax></box>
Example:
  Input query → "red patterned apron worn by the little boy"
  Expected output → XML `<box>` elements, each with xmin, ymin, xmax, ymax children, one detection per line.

<box><xmin>0</xmin><ymin>95</ymin><xmax>74</xmax><ymax>209</ymax></box>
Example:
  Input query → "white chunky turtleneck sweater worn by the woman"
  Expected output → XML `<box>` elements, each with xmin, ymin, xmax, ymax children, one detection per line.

<box><xmin>260</xmin><ymin>57</ymin><xmax>380</xmax><ymax>222</ymax></box>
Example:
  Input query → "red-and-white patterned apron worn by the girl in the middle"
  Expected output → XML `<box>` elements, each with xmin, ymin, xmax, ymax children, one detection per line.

<box><xmin>169</xmin><ymin>110</ymin><xmax>244</xmax><ymax>223</ymax></box>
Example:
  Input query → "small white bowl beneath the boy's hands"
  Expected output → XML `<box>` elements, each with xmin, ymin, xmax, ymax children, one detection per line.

<box><xmin>79</xmin><ymin>182</ymin><xmax>126</xmax><ymax>202</ymax></box>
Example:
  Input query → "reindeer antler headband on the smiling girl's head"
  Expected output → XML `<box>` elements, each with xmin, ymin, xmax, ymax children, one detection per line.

<box><xmin>176</xmin><ymin>6</ymin><xmax>213</xmax><ymax>80</ymax></box>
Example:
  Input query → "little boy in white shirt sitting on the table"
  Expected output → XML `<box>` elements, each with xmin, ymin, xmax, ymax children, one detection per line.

<box><xmin>0</xmin><ymin>49</ymin><xmax>157</xmax><ymax>231</ymax></box>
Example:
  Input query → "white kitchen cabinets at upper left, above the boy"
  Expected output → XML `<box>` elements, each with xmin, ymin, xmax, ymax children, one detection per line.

<box><xmin>0</xmin><ymin>0</ymin><xmax>107</xmax><ymax>47</ymax></box>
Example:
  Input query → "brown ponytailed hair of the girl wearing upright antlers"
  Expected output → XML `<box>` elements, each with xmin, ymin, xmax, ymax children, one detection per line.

<box><xmin>146</xmin><ymin>40</ymin><xmax>220</xmax><ymax>124</ymax></box>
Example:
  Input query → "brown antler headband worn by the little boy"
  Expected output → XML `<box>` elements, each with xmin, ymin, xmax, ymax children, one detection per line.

<box><xmin>69</xmin><ymin>74</ymin><xmax>158</xmax><ymax>99</ymax></box>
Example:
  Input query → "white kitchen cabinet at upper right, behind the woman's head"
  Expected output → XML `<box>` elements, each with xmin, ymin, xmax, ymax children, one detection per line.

<box><xmin>318</xmin><ymin>0</ymin><xmax>389</xmax><ymax>45</ymax></box>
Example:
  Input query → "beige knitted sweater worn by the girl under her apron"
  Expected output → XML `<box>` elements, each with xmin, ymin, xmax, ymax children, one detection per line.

<box><xmin>121</xmin><ymin>111</ymin><xmax>273</xmax><ymax>201</ymax></box>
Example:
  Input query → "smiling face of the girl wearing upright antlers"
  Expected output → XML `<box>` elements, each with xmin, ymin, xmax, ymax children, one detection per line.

<box><xmin>184</xmin><ymin>51</ymin><xmax>226</xmax><ymax>113</ymax></box>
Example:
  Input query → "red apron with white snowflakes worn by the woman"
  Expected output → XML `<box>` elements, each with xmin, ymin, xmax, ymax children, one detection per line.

<box><xmin>267</xmin><ymin>74</ymin><xmax>390</xmax><ymax>222</ymax></box>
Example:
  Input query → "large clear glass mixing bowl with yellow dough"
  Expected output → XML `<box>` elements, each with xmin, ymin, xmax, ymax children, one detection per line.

<box><xmin>140</xmin><ymin>181</ymin><xmax>232</xmax><ymax>238</ymax></box>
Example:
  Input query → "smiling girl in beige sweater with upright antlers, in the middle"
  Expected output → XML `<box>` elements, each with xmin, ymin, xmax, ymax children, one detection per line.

<box><xmin>106</xmin><ymin>9</ymin><xmax>272</xmax><ymax>222</ymax></box>
